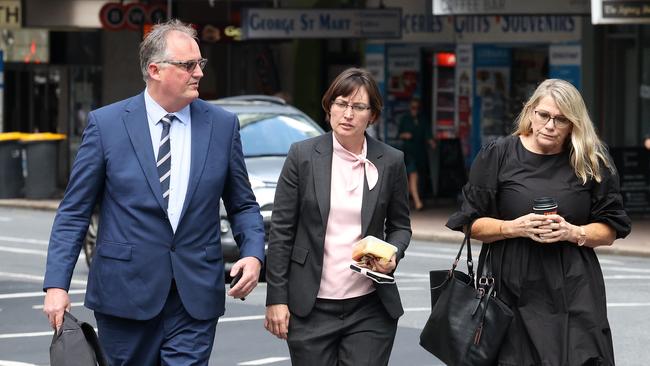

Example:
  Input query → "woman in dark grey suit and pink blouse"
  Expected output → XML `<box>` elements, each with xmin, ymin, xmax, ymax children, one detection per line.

<box><xmin>265</xmin><ymin>68</ymin><xmax>411</xmax><ymax>366</ymax></box>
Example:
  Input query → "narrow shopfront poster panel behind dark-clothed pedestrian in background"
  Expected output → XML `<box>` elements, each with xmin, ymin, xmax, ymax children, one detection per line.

<box><xmin>384</xmin><ymin>45</ymin><xmax>421</xmax><ymax>147</ymax></box>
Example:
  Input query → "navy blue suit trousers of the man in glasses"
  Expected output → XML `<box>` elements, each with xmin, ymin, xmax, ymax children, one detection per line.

<box><xmin>95</xmin><ymin>286</ymin><xmax>219</xmax><ymax>366</ymax></box>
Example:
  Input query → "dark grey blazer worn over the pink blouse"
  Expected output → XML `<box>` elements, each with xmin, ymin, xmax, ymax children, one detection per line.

<box><xmin>266</xmin><ymin>132</ymin><xmax>411</xmax><ymax>318</ymax></box>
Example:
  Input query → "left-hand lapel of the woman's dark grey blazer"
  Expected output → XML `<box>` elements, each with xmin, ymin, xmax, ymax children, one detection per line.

<box><xmin>312</xmin><ymin>132</ymin><xmax>334</xmax><ymax>230</ymax></box>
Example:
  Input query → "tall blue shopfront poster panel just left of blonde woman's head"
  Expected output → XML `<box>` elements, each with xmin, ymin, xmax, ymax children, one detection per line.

<box><xmin>471</xmin><ymin>45</ymin><xmax>512</xmax><ymax>157</ymax></box>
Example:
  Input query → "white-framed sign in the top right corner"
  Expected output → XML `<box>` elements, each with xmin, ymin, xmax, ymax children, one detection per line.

<box><xmin>591</xmin><ymin>0</ymin><xmax>650</xmax><ymax>24</ymax></box>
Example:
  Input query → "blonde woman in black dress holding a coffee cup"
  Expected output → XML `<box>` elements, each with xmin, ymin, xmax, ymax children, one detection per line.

<box><xmin>447</xmin><ymin>79</ymin><xmax>630</xmax><ymax>366</ymax></box>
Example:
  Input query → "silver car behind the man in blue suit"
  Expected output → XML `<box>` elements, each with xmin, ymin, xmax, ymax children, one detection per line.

<box><xmin>84</xmin><ymin>95</ymin><xmax>323</xmax><ymax>280</ymax></box>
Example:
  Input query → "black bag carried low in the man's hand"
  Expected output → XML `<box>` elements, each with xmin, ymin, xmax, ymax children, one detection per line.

<box><xmin>50</xmin><ymin>311</ymin><xmax>108</xmax><ymax>366</ymax></box>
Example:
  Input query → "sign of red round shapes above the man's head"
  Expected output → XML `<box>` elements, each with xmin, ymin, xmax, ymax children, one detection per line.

<box><xmin>99</xmin><ymin>3</ymin><xmax>167</xmax><ymax>31</ymax></box>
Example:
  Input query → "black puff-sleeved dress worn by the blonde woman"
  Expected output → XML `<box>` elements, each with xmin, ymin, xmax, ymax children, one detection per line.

<box><xmin>447</xmin><ymin>136</ymin><xmax>630</xmax><ymax>366</ymax></box>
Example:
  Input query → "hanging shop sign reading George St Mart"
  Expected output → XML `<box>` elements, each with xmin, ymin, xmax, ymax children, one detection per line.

<box><xmin>242</xmin><ymin>8</ymin><xmax>401</xmax><ymax>39</ymax></box>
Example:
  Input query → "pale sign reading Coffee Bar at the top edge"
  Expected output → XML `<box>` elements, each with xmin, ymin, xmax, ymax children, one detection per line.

<box><xmin>432</xmin><ymin>0</ymin><xmax>593</xmax><ymax>15</ymax></box>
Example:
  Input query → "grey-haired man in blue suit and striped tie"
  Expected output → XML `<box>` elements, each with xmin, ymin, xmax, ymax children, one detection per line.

<box><xmin>43</xmin><ymin>20</ymin><xmax>264</xmax><ymax>366</ymax></box>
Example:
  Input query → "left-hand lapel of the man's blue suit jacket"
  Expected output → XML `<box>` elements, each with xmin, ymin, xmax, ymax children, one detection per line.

<box><xmin>122</xmin><ymin>94</ymin><xmax>165</xmax><ymax>210</ymax></box>
